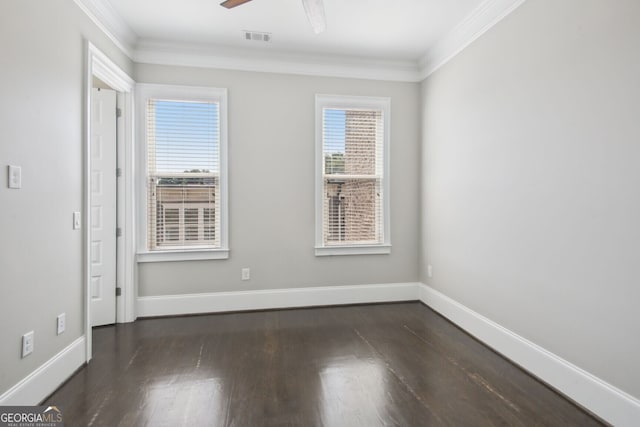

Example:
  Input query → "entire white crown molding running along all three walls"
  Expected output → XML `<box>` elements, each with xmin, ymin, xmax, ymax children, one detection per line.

<box><xmin>74</xmin><ymin>0</ymin><xmax>525</xmax><ymax>82</ymax></box>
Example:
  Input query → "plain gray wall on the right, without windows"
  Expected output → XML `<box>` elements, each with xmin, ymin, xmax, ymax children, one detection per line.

<box><xmin>420</xmin><ymin>0</ymin><xmax>640</xmax><ymax>397</ymax></box>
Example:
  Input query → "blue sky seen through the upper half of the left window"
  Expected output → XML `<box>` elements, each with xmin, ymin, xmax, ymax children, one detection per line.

<box><xmin>153</xmin><ymin>99</ymin><xmax>220</xmax><ymax>174</ymax></box>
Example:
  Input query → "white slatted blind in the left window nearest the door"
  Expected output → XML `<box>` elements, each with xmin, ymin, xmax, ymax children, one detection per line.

<box><xmin>145</xmin><ymin>98</ymin><xmax>221</xmax><ymax>251</ymax></box>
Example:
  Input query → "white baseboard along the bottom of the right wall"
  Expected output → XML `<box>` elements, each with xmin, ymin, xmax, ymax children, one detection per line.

<box><xmin>419</xmin><ymin>284</ymin><xmax>640</xmax><ymax>427</ymax></box>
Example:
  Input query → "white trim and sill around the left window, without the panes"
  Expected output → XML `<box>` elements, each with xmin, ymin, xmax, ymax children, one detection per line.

<box><xmin>136</xmin><ymin>83</ymin><xmax>229</xmax><ymax>263</ymax></box>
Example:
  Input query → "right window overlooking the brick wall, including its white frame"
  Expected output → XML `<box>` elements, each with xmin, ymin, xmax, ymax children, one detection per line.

<box><xmin>316</xmin><ymin>95</ymin><xmax>391</xmax><ymax>255</ymax></box>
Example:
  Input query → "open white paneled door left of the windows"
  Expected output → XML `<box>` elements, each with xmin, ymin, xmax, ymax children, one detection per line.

<box><xmin>90</xmin><ymin>89</ymin><xmax>116</xmax><ymax>326</ymax></box>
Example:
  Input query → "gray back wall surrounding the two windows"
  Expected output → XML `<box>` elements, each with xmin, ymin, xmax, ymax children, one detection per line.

<box><xmin>135</xmin><ymin>64</ymin><xmax>420</xmax><ymax>296</ymax></box>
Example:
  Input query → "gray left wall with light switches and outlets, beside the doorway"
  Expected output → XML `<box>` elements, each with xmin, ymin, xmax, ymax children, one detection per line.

<box><xmin>0</xmin><ymin>0</ymin><xmax>133</xmax><ymax>394</ymax></box>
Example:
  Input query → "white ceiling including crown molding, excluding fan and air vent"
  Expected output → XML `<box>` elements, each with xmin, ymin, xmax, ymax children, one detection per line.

<box><xmin>75</xmin><ymin>0</ymin><xmax>524</xmax><ymax>80</ymax></box>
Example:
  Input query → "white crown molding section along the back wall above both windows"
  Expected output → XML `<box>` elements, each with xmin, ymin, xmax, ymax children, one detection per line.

<box><xmin>133</xmin><ymin>39</ymin><xmax>420</xmax><ymax>82</ymax></box>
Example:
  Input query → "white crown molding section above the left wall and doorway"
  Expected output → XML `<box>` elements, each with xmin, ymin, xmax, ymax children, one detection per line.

<box><xmin>73</xmin><ymin>0</ymin><xmax>138</xmax><ymax>58</ymax></box>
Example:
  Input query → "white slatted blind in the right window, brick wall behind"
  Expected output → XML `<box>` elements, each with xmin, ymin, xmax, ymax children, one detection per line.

<box><xmin>319</xmin><ymin>97</ymin><xmax>388</xmax><ymax>251</ymax></box>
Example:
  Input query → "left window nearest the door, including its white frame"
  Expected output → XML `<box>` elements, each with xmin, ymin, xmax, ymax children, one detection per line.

<box><xmin>138</xmin><ymin>84</ymin><xmax>228</xmax><ymax>261</ymax></box>
